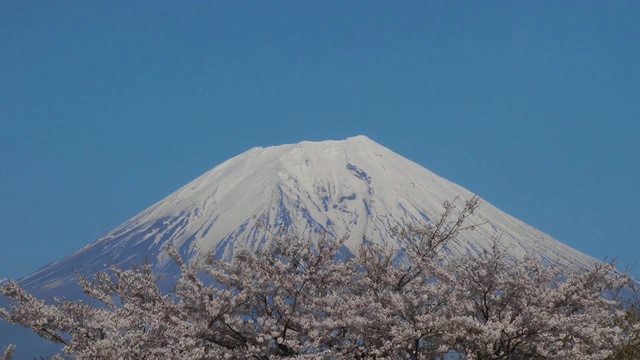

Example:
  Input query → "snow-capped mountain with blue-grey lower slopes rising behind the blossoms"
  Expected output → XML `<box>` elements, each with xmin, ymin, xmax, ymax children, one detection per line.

<box><xmin>21</xmin><ymin>136</ymin><xmax>597</xmax><ymax>295</ymax></box>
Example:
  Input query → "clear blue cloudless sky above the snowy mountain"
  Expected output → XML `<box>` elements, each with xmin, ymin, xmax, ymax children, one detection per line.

<box><xmin>0</xmin><ymin>0</ymin><xmax>640</xmax><ymax>278</ymax></box>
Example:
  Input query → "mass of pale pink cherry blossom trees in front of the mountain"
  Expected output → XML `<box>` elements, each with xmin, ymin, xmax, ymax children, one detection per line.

<box><xmin>0</xmin><ymin>197</ymin><xmax>637</xmax><ymax>360</ymax></box>
